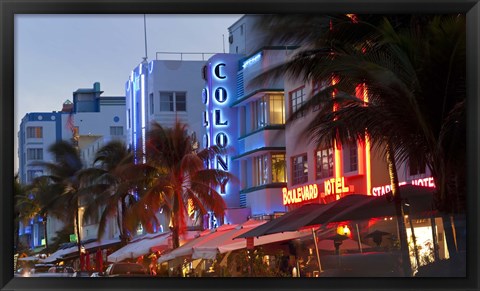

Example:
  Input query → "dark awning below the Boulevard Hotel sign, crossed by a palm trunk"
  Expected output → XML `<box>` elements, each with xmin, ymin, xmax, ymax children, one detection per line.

<box><xmin>238</xmin><ymin>185</ymin><xmax>435</xmax><ymax>238</ymax></box>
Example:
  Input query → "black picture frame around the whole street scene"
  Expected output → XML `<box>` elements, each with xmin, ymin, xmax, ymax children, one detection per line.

<box><xmin>0</xmin><ymin>0</ymin><xmax>480</xmax><ymax>291</ymax></box>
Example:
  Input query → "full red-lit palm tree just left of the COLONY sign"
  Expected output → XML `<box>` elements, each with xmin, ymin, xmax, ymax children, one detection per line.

<box><xmin>125</xmin><ymin>122</ymin><xmax>234</xmax><ymax>248</ymax></box>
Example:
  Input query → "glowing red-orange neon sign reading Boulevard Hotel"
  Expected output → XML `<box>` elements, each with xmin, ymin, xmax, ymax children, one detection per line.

<box><xmin>282</xmin><ymin>177</ymin><xmax>354</xmax><ymax>205</ymax></box>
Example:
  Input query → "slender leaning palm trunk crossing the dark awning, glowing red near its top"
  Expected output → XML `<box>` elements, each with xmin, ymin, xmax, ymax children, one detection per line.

<box><xmin>386</xmin><ymin>141</ymin><xmax>412</xmax><ymax>277</ymax></box>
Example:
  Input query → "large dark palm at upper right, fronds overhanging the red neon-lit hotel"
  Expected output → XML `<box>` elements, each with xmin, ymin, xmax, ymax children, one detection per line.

<box><xmin>255</xmin><ymin>15</ymin><xmax>465</xmax><ymax>274</ymax></box>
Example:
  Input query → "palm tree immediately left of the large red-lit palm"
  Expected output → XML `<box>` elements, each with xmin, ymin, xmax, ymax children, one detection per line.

<box><xmin>80</xmin><ymin>141</ymin><xmax>139</xmax><ymax>244</ymax></box>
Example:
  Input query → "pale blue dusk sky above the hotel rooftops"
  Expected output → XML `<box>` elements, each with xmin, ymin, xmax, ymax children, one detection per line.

<box><xmin>14</xmin><ymin>14</ymin><xmax>242</xmax><ymax>172</ymax></box>
